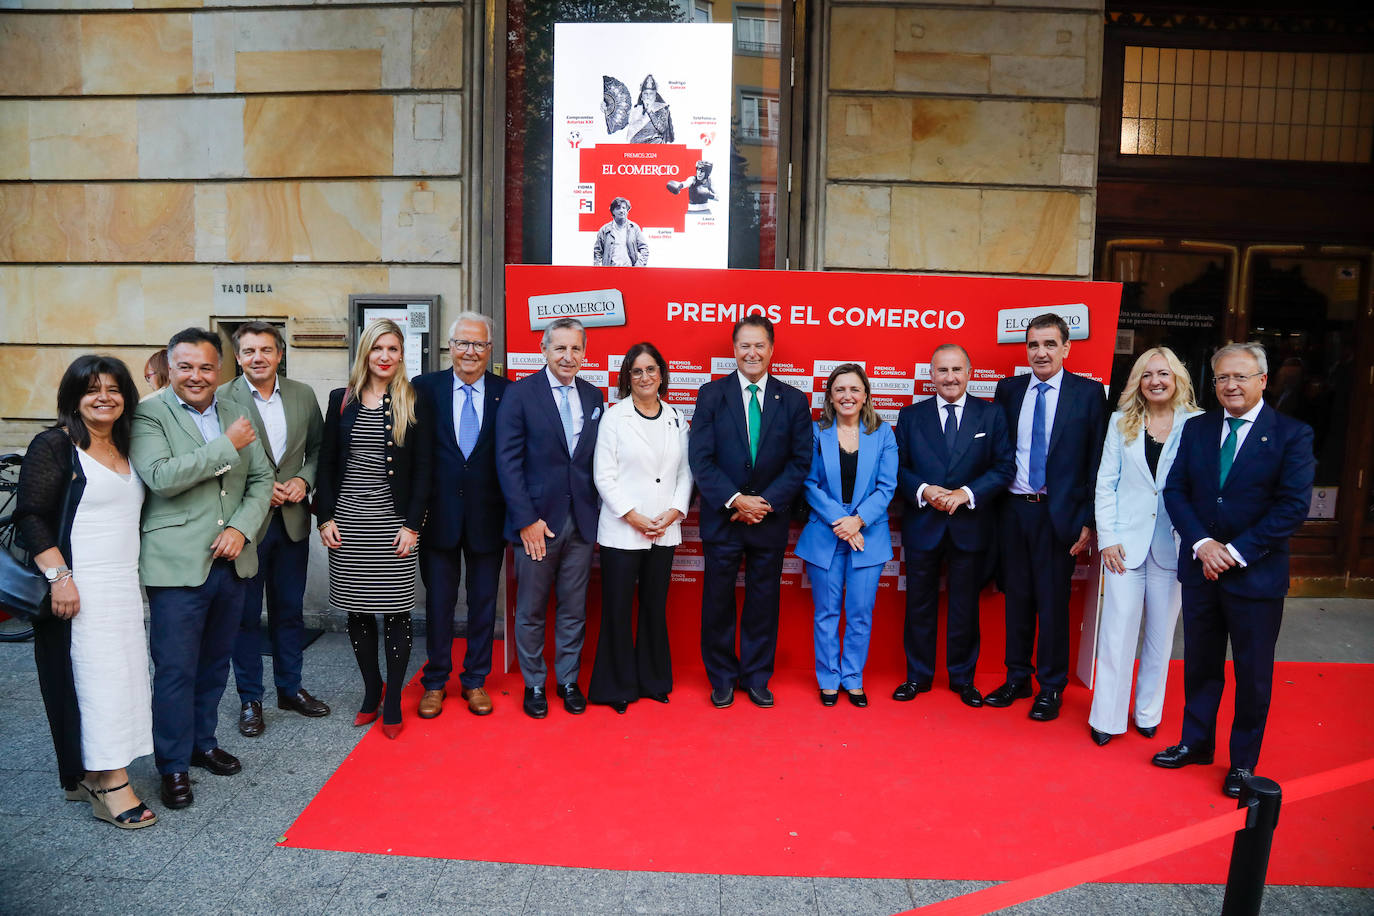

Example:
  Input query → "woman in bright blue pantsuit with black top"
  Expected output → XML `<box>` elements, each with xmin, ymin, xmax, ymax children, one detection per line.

<box><xmin>797</xmin><ymin>363</ymin><xmax>897</xmax><ymax>706</ymax></box>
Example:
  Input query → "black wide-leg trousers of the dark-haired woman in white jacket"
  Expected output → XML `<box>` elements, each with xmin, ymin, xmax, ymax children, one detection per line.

<box><xmin>587</xmin><ymin>545</ymin><xmax>675</xmax><ymax>703</ymax></box>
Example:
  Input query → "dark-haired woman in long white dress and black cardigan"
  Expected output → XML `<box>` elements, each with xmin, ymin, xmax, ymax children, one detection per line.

<box><xmin>15</xmin><ymin>356</ymin><xmax>157</xmax><ymax>829</ymax></box>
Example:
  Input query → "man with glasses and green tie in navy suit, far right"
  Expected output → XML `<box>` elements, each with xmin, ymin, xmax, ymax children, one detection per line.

<box><xmin>1154</xmin><ymin>343</ymin><xmax>1316</xmax><ymax>798</ymax></box>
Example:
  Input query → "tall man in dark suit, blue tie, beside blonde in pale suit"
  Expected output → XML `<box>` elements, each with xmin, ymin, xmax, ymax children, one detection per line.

<box><xmin>985</xmin><ymin>313</ymin><xmax>1107</xmax><ymax>722</ymax></box>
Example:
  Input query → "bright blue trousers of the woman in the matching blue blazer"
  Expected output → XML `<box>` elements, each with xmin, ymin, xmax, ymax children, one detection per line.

<box><xmin>807</xmin><ymin>540</ymin><xmax>882</xmax><ymax>691</ymax></box>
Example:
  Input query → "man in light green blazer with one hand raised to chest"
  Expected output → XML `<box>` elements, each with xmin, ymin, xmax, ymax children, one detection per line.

<box><xmin>129</xmin><ymin>328</ymin><xmax>272</xmax><ymax>808</ymax></box>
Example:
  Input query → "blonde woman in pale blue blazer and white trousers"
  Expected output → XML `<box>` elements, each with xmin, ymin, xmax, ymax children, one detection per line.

<box><xmin>1088</xmin><ymin>347</ymin><xmax>1200</xmax><ymax>746</ymax></box>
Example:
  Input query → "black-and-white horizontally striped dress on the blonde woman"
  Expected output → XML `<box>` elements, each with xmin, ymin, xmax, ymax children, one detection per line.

<box><xmin>330</xmin><ymin>405</ymin><xmax>419</xmax><ymax>614</ymax></box>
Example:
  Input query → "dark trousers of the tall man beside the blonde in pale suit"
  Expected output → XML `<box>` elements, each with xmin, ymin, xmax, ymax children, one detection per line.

<box><xmin>1002</xmin><ymin>493</ymin><xmax>1077</xmax><ymax>689</ymax></box>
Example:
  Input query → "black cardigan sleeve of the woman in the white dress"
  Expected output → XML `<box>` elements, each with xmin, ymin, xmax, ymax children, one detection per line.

<box><xmin>14</xmin><ymin>427</ymin><xmax>85</xmax><ymax>566</ymax></box>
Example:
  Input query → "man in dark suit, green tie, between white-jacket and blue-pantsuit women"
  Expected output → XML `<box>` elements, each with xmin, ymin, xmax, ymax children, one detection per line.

<box><xmin>687</xmin><ymin>314</ymin><xmax>812</xmax><ymax>709</ymax></box>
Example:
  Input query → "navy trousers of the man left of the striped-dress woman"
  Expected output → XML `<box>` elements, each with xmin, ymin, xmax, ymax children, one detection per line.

<box><xmin>234</xmin><ymin>509</ymin><xmax>311</xmax><ymax>703</ymax></box>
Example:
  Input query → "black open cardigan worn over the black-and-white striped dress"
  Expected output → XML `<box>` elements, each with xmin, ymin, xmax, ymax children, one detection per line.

<box><xmin>315</xmin><ymin>389</ymin><xmax>434</xmax><ymax>531</ymax></box>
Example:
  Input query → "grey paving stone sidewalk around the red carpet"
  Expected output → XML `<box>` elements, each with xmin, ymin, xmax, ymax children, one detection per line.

<box><xmin>0</xmin><ymin>599</ymin><xmax>1374</xmax><ymax>916</ymax></box>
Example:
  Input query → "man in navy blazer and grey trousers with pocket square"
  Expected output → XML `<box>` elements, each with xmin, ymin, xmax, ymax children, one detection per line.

<box><xmin>496</xmin><ymin>319</ymin><xmax>603</xmax><ymax>718</ymax></box>
